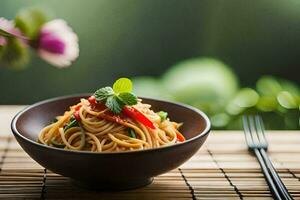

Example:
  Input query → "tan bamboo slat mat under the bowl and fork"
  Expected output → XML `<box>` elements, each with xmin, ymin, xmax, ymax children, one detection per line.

<box><xmin>0</xmin><ymin>131</ymin><xmax>300</xmax><ymax>200</ymax></box>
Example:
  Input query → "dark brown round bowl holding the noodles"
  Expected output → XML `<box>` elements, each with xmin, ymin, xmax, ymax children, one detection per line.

<box><xmin>11</xmin><ymin>95</ymin><xmax>210</xmax><ymax>190</ymax></box>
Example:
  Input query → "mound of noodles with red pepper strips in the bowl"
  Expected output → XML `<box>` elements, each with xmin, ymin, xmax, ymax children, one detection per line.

<box><xmin>38</xmin><ymin>99</ymin><xmax>182</xmax><ymax>152</ymax></box>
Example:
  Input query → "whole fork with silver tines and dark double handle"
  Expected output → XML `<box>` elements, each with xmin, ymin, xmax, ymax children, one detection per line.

<box><xmin>243</xmin><ymin>115</ymin><xmax>293</xmax><ymax>200</ymax></box>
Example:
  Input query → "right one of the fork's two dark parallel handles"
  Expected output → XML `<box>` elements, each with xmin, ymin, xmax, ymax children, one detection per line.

<box><xmin>259</xmin><ymin>149</ymin><xmax>293</xmax><ymax>200</ymax></box>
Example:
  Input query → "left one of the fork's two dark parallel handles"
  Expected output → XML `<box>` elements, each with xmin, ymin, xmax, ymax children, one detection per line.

<box><xmin>254</xmin><ymin>149</ymin><xmax>282</xmax><ymax>200</ymax></box>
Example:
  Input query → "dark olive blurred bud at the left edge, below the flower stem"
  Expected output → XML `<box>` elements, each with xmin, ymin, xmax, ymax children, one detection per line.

<box><xmin>0</xmin><ymin>38</ymin><xmax>29</xmax><ymax>69</ymax></box>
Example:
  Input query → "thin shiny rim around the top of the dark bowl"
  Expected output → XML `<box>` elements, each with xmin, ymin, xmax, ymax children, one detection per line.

<box><xmin>11</xmin><ymin>93</ymin><xmax>211</xmax><ymax>155</ymax></box>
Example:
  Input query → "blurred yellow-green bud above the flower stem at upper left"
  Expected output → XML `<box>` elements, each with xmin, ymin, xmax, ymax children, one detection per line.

<box><xmin>15</xmin><ymin>9</ymin><xmax>47</xmax><ymax>39</ymax></box>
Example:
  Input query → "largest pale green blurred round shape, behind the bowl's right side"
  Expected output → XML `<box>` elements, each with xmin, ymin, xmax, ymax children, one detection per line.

<box><xmin>162</xmin><ymin>57</ymin><xmax>238</xmax><ymax>109</ymax></box>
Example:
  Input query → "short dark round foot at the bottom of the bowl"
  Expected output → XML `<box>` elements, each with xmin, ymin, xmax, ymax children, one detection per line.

<box><xmin>71</xmin><ymin>178</ymin><xmax>153</xmax><ymax>191</ymax></box>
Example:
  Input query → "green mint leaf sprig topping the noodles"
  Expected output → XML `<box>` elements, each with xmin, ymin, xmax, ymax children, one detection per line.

<box><xmin>94</xmin><ymin>78</ymin><xmax>138</xmax><ymax>113</ymax></box>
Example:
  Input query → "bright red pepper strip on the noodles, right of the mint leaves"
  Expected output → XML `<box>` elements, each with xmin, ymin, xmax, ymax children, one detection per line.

<box><xmin>123</xmin><ymin>106</ymin><xmax>155</xmax><ymax>129</ymax></box>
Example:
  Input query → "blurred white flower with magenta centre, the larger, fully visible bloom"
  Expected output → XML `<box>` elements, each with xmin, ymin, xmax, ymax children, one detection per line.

<box><xmin>37</xmin><ymin>19</ymin><xmax>79</xmax><ymax>67</ymax></box>
